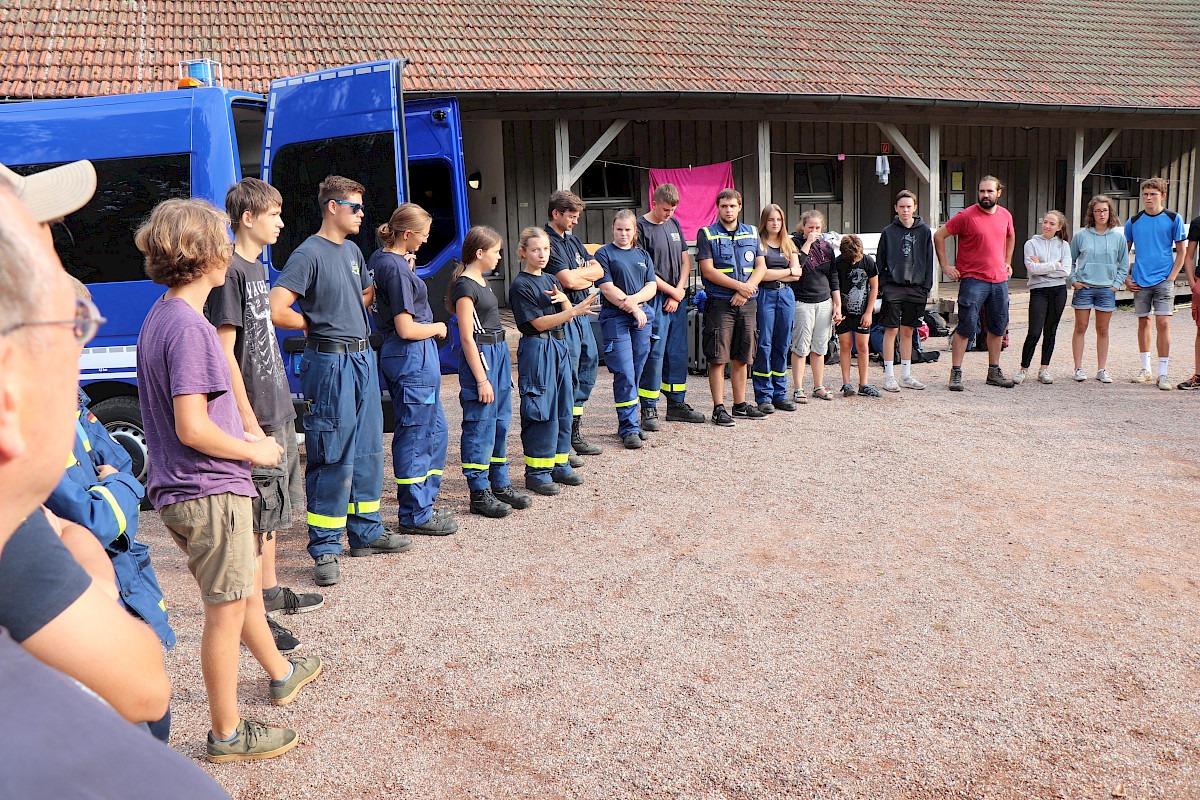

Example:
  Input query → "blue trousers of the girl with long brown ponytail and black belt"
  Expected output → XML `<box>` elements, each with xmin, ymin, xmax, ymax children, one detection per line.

<box><xmin>458</xmin><ymin>342</ymin><xmax>512</xmax><ymax>492</ymax></box>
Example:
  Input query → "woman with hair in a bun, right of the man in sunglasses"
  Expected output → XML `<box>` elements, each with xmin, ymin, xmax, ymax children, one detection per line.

<box><xmin>367</xmin><ymin>203</ymin><xmax>458</xmax><ymax>537</ymax></box>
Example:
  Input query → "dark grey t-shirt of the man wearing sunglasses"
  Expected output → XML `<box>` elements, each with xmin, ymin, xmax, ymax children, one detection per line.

<box><xmin>275</xmin><ymin>234</ymin><xmax>371</xmax><ymax>342</ymax></box>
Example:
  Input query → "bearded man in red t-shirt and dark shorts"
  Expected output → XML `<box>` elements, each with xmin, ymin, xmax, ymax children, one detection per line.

<box><xmin>934</xmin><ymin>175</ymin><xmax>1016</xmax><ymax>392</ymax></box>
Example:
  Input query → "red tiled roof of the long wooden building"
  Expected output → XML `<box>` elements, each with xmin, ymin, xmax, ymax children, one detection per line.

<box><xmin>7</xmin><ymin>0</ymin><xmax>1200</xmax><ymax>108</ymax></box>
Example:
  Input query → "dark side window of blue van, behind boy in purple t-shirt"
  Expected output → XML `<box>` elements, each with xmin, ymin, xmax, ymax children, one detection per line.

<box><xmin>12</xmin><ymin>154</ymin><xmax>192</xmax><ymax>283</ymax></box>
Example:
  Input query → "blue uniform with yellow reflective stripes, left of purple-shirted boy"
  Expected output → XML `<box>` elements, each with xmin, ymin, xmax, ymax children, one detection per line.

<box><xmin>46</xmin><ymin>393</ymin><xmax>175</xmax><ymax>649</ymax></box>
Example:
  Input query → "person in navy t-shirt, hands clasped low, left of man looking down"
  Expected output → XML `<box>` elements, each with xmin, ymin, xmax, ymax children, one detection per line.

<box><xmin>596</xmin><ymin>209</ymin><xmax>659</xmax><ymax>450</ymax></box>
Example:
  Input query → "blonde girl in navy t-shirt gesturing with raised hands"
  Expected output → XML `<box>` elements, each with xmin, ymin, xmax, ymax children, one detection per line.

<box><xmin>509</xmin><ymin>228</ymin><xmax>599</xmax><ymax>494</ymax></box>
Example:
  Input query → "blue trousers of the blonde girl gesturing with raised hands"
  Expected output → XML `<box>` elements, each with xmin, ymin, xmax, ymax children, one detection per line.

<box><xmin>517</xmin><ymin>336</ymin><xmax>575</xmax><ymax>485</ymax></box>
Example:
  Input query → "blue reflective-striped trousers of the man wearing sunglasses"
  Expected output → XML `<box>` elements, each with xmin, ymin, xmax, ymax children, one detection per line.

<box><xmin>300</xmin><ymin>350</ymin><xmax>384</xmax><ymax>559</ymax></box>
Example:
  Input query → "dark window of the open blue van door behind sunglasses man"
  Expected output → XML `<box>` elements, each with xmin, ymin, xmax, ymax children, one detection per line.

<box><xmin>270</xmin><ymin>131</ymin><xmax>396</xmax><ymax>270</ymax></box>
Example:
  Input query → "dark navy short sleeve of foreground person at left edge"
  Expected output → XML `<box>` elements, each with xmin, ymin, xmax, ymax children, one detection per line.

<box><xmin>0</xmin><ymin>509</ymin><xmax>91</xmax><ymax>642</ymax></box>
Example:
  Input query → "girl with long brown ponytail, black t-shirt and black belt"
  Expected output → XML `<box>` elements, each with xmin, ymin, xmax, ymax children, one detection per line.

<box><xmin>446</xmin><ymin>225</ymin><xmax>533</xmax><ymax>517</ymax></box>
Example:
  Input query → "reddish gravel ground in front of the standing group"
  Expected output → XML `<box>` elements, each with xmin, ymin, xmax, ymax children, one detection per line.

<box><xmin>142</xmin><ymin>307</ymin><xmax>1200</xmax><ymax>800</ymax></box>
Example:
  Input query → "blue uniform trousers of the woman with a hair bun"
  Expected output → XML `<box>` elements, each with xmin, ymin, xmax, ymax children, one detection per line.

<box><xmin>379</xmin><ymin>338</ymin><xmax>448</xmax><ymax>525</ymax></box>
